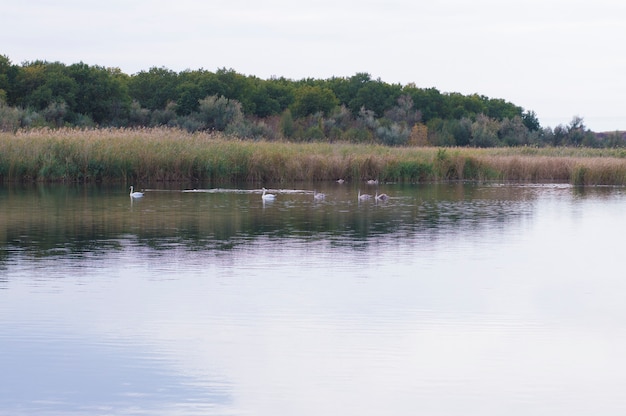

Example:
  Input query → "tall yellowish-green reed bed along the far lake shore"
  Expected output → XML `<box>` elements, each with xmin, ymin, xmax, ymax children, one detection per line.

<box><xmin>0</xmin><ymin>129</ymin><xmax>626</xmax><ymax>185</ymax></box>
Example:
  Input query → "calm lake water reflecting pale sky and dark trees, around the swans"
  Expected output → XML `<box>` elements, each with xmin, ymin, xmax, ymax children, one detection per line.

<box><xmin>0</xmin><ymin>183</ymin><xmax>626</xmax><ymax>416</ymax></box>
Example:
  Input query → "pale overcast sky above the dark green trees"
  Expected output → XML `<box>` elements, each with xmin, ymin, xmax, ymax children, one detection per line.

<box><xmin>0</xmin><ymin>0</ymin><xmax>626</xmax><ymax>132</ymax></box>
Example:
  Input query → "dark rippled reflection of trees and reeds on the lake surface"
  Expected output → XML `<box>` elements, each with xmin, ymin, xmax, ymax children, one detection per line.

<box><xmin>0</xmin><ymin>184</ymin><xmax>533</xmax><ymax>256</ymax></box>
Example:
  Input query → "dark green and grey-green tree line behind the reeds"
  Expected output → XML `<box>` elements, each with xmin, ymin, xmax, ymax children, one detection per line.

<box><xmin>0</xmin><ymin>55</ymin><xmax>624</xmax><ymax>147</ymax></box>
